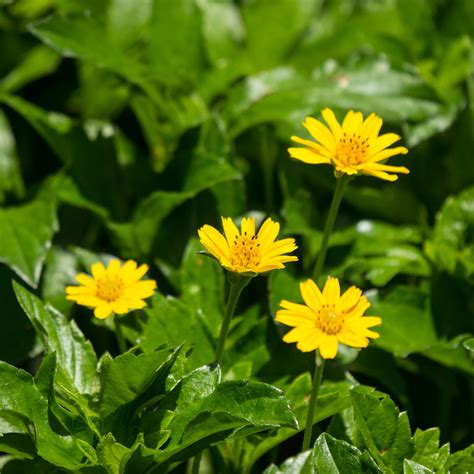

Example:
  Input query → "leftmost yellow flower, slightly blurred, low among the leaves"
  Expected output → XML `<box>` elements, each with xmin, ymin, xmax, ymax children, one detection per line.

<box><xmin>66</xmin><ymin>259</ymin><xmax>156</xmax><ymax>319</ymax></box>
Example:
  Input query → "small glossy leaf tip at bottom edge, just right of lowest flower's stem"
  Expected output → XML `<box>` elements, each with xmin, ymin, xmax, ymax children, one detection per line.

<box><xmin>313</xmin><ymin>433</ymin><xmax>382</xmax><ymax>474</ymax></box>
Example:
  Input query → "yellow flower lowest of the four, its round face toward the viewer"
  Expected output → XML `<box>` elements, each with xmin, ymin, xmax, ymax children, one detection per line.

<box><xmin>276</xmin><ymin>278</ymin><xmax>382</xmax><ymax>359</ymax></box>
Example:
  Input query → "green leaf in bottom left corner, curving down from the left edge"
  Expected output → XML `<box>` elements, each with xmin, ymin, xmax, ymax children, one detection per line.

<box><xmin>0</xmin><ymin>361</ymin><xmax>88</xmax><ymax>470</ymax></box>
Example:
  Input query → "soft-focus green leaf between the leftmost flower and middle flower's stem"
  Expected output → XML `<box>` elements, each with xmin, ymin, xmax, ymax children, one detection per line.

<box><xmin>140</xmin><ymin>293</ymin><xmax>218</xmax><ymax>367</ymax></box>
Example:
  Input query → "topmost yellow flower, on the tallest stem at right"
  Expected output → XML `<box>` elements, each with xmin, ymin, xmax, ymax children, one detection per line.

<box><xmin>288</xmin><ymin>108</ymin><xmax>409</xmax><ymax>181</ymax></box>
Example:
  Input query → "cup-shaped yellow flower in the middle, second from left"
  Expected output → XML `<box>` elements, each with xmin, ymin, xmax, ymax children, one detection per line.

<box><xmin>198</xmin><ymin>217</ymin><xmax>298</xmax><ymax>274</ymax></box>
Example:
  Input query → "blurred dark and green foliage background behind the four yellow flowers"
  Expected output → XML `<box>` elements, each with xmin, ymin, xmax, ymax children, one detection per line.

<box><xmin>0</xmin><ymin>0</ymin><xmax>474</xmax><ymax>462</ymax></box>
